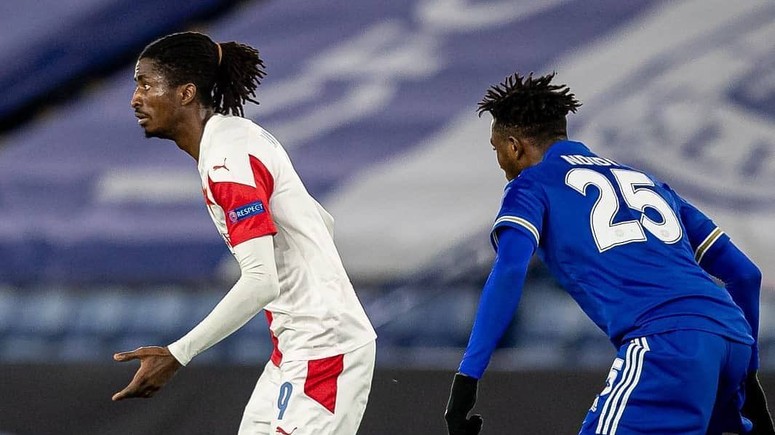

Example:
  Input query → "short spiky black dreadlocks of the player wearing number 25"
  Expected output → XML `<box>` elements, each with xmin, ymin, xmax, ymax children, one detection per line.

<box><xmin>477</xmin><ymin>72</ymin><xmax>581</xmax><ymax>139</ymax></box>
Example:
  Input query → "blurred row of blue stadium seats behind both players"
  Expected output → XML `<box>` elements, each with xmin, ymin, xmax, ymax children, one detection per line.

<box><xmin>0</xmin><ymin>271</ymin><xmax>775</xmax><ymax>371</ymax></box>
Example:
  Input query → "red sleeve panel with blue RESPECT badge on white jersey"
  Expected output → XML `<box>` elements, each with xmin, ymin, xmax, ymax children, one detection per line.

<box><xmin>208</xmin><ymin>156</ymin><xmax>277</xmax><ymax>246</ymax></box>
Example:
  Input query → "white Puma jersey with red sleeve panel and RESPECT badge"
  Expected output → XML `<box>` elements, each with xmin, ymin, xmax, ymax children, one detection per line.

<box><xmin>198</xmin><ymin>114</ymin><xmax>376</xmax><ymax>366</ymax></box>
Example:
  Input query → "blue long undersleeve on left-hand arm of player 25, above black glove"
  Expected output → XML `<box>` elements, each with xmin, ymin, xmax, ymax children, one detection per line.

<box><xmin>458</xmin><ymin>227</ymin><xmax>535</xmax><ymax>379</ymax></box>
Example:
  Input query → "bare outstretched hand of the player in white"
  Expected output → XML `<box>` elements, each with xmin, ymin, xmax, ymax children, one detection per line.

<box><xmin>113</xmin><ymin>346</ymin><xmax>182</xmax><ymax>401</ymax></box>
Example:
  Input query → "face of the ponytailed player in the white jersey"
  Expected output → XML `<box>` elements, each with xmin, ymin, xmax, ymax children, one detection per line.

<box><xmin>131</xmin><ymin>59</ymin><xmax>183</xmax><ymax>139</ymax></box>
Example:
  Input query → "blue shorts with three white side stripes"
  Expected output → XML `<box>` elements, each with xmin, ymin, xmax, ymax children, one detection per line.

<box><xmin>579</xmin><ymin>330</ymin><xmax>751</xmax><ymax>435</ymax></box>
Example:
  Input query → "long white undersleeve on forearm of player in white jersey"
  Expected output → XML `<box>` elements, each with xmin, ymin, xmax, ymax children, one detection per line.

<box><xmin>169</xmin><ymin>236</ymin><xmax>280</xmax><ymax>365</ymax></box>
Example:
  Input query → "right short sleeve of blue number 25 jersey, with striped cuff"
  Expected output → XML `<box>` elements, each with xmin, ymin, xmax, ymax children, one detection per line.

<box><xmin>667</xmin><ymin>187</ymin><xmax>729</xmax><ymax>264</ymax></box>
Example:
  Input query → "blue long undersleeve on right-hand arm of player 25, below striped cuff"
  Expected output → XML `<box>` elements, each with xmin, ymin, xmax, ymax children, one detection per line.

<box><xmin>700</xmin><ymin>239</ymin><xmax>762</xmax><ymax>371</ymax></box>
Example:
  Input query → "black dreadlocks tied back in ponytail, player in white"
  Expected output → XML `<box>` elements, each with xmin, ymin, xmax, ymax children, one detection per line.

<box><xmin>140</xmin><ymin>32</ymin><xmax>266</xmax><ymax>116</ymax></box>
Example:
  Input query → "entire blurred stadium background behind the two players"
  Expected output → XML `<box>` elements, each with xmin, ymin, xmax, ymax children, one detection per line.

<box><xmin>0</xmin><ymin>0</ymin><xmax>775</xmax><ymax>435</ymax></box>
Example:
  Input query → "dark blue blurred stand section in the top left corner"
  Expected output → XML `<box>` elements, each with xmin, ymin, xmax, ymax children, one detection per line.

<box><xmin>0</xmin><ymin>0</ymin><xmax>242</xmax><ymax>120</ymax></box>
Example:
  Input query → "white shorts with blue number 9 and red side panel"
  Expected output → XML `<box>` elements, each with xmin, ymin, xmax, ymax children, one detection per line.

<box><xmin>239</xmin><ymin>341</ymin><xmax>376</xmax><ymax>435</ymax></box>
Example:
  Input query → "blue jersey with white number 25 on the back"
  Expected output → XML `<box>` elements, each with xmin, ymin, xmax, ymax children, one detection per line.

<box><xmin>492</xmin><ymin>141</ymin><xmax>754</xmax><ymax>347</ymax></box>
